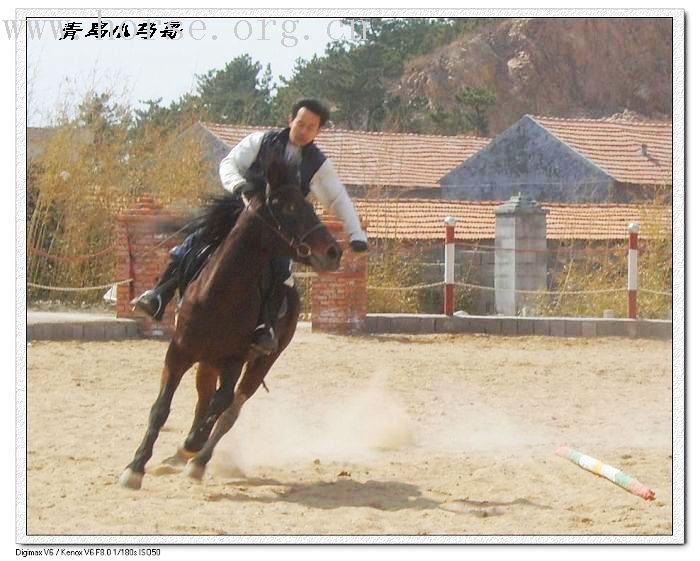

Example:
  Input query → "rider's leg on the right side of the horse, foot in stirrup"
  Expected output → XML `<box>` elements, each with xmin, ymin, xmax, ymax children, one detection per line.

<box><xmin>252</xmin><ymin>257</ymin><xmax>293</xmax><ymax>355</ymax></box>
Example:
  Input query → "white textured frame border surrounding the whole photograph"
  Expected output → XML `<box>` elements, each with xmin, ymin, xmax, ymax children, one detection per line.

<box><xmin>15</xmin><ymin>8</ymin><xmax>686</xmax><ymax>545</ymax></box>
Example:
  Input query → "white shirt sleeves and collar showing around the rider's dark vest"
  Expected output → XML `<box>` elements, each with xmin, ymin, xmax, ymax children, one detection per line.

<box><xmin>219</xmin><ymin>132</ymin><xmax>367</xmax><ymax>243</ymax></box>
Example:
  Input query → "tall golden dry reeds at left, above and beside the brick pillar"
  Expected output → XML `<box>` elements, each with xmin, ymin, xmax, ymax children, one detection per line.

<box><xmin>27</xmin><ymin>94</ymin><xmax>208</xmax><ymax>302</ymax></box>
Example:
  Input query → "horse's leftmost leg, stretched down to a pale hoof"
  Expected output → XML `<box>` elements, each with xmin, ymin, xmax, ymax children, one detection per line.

<box><xmin>119</xmin><ymin>343</ymin><xmax>192</xmax><ymax>489</ymax></box>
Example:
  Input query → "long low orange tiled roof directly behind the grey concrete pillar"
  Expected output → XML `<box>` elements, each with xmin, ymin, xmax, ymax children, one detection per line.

<box><xmin>354</xmin><ymin>199</ymin><xmax>671</xmax><ymax>240</ymax></box>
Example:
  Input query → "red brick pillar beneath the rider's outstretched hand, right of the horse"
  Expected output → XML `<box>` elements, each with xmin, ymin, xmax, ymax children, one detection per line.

<box><xmin>311</xmin><ymin>217</ymin><xmax>367</xmax><ymax>335</ymax></box>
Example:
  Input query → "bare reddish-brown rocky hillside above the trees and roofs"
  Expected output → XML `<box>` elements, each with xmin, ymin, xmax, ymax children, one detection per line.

<box><xmin>395</xmin><ymin>18</ymin><xmax>672</xmax><ymax>135</ymax></box>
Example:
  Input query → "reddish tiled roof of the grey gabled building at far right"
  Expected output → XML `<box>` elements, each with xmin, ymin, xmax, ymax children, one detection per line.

<box><xmin>532</xmin><ymin>116</ymin><xmax>673</xmax><ymax>185</ymax></box>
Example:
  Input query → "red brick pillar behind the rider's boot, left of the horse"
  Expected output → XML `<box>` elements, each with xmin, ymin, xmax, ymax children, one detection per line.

<box><xmin>117</xmin><ymin>196</ymin><xmax>181</xmax><ymax>337</ymax></box>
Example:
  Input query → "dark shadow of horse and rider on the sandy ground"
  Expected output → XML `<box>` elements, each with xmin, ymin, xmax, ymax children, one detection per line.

<box><xmin>208</xmin><ymin>479</ymin><xmax>441</xmax><ymax>511</ymax></box>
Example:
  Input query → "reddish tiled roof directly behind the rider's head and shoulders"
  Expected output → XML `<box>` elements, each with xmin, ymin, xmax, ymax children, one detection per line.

<box><xmin>202</xmin><ymin>123</ymin><xmax>491</xmax><ymax>189</ymax></box>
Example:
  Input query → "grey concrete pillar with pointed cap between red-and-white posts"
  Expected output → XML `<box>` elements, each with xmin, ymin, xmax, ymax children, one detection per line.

<box><xmin>494</xmin><ymin>194</ymin><xmax>548</xmax><ymax>316</ymax></box>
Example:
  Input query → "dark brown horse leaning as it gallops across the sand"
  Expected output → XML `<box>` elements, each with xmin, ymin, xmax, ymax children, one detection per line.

<box><xmin>119</xmin><ymin>163</ymin><xmax>342</xmax><ymax>489</ymax></box>
